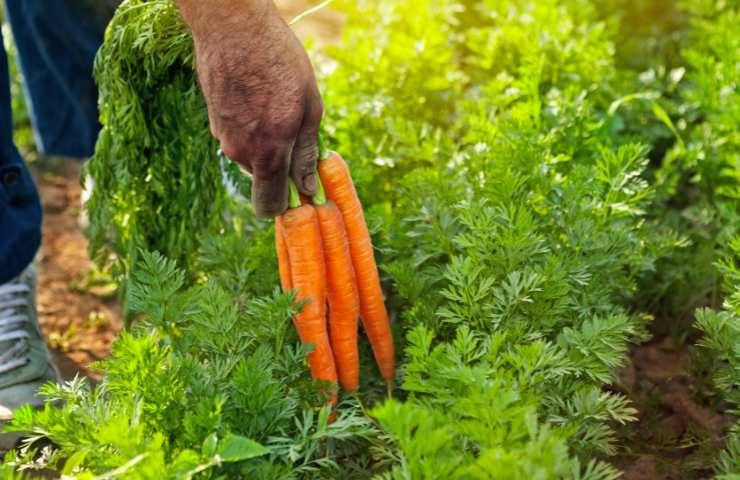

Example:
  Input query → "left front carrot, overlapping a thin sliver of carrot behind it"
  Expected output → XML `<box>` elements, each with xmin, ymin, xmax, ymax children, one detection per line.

<box><xmin>280</xmin><ymin>185</ymin><xmax>337</xmax><ymax>405</ymax></box>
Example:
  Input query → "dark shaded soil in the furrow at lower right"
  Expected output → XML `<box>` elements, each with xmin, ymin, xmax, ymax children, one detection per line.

<box><xmin>612</xmin><ymin>337</ymin><xmax>734</xmax><ymax>480</ymax></box>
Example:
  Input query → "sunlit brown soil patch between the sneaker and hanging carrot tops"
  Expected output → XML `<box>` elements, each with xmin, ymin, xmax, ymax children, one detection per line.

<box><xmin>34</xmin><ymin>159</ymin><xmax>121</xmax><ymax>380</ymax></box>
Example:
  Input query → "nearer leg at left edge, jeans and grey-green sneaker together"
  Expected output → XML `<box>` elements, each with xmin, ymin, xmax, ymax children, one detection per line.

<box><xmin>0</xmin><ymin>27</ymin><xmax>57</xmax><ymax>450</ymax></box>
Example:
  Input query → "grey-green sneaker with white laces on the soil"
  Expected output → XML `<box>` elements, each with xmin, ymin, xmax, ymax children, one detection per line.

<box><xmin>0</xmin><ymin>266</ymin><xmax>59</xmax><ymax>450</ymax></box>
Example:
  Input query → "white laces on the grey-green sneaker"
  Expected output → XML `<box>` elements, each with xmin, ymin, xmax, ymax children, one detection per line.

<box><xmin>0</xmin><ymin>281</ymin><xmax>31</xmax><ymax>374</ymax></box>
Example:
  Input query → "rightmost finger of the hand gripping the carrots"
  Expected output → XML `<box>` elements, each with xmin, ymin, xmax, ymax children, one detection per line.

<box><xmin>290</xmin><ymin>88</ymin><xmax>324</xmax><ymax>196</ymax></box>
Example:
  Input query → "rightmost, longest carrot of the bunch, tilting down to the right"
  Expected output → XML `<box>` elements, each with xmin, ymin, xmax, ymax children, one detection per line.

<box><xmin>318</xmin><ymin>152</ymin><xmax>395</xmax><ymax>384</ymax></box>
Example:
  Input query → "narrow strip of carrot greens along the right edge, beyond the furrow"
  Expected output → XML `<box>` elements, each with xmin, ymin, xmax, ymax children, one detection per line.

<box><xmin>684</xmin><ymin>2</ymin><xmax>740</xmax><ymax>479</ymax></box>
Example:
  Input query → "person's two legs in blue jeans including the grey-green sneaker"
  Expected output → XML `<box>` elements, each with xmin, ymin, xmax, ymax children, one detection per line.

<box><xmin>0</xmin><ymin>0</ymin><xmax>118</xmax><ymax>444</ymax></box>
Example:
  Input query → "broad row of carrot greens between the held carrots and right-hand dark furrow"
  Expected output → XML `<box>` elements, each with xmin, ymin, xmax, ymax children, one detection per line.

<box><xmin>325</xmin><ymin>2</ymin><xmax>679</xmax><ymax>478</ymax></box>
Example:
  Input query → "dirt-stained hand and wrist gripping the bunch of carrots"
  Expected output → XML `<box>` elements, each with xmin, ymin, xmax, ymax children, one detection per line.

<box><xmin>180</xmin><ymin>0</ymin><xmax>323</xmax><ymax>217</ymax></box>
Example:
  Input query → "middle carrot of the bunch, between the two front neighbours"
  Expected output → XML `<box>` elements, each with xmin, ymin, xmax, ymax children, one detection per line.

<box><xmin>314</xmin><ymin>182</ymin><xmax>360</xmax><ymax>390</ymax></box>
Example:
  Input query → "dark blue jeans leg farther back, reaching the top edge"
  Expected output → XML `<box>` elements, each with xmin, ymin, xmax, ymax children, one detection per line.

<box><xmin>5</xmin><ymin>0</ymin><xmax>110</xmax><ymax>158</ymax></box>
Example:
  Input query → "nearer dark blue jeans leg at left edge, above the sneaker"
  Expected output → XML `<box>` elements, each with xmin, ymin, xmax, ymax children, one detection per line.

<box><xmin>0</xmin><ymin>26</ymin><xmax>41</xmax><ymax>285</ymax></box>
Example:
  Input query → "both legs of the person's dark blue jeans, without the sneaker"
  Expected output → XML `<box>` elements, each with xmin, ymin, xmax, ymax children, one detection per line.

<box><xmin>0</xmin><ymin>0</ymin><xmax>110</xmax><ymax>284</ymax></box>
